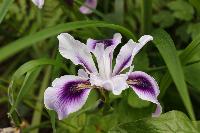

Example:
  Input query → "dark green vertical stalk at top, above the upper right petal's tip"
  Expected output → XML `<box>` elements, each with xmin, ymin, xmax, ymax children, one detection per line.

<box><xmin>141</xmin><ymin>0</ymin><xmax>152</xmax><ymax>34</ymax></box>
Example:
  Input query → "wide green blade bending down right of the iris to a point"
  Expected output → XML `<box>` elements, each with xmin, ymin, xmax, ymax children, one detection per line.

<box><xmin>152</xmin><ymin>30</ymin><xmax>195</xmax><ymax>120</ymax></box>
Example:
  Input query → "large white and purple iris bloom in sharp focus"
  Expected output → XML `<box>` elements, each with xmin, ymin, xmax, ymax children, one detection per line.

<box><xmin>44</xmin><ymin>33</ymin><xmax>162</xmax><ymax>120</ymax></box>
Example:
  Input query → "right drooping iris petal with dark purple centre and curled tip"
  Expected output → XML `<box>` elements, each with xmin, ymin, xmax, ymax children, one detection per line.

<box><xmin>127</xmin><ymin>71</ymin><xmax>162</xmax><ymax>116</ymax></box>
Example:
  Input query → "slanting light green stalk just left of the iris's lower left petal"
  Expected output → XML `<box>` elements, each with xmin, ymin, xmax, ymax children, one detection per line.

<box><xmin>31</xmin><ymin>66</ymin><xmax>51</xmax><ymax>133</ymax></box>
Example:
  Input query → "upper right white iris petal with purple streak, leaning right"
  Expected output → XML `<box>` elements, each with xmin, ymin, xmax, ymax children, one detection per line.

<box><xmin>113</xmin><ymin>35</ymin><xmax>153</xmax><ymax>75</ymax></box>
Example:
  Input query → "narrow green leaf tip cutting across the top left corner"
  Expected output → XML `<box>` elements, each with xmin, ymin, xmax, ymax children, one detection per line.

<box><xmin>0</xmin><ymin>0</ymin><xmax>14</xmax><ymax>24</ymax></box>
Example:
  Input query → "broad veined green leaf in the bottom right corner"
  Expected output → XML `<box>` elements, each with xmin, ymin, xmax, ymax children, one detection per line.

<box><xmin>109</xmin><ymin>111</ymin><xmax>198</xmax><ymax>133</ymax></box>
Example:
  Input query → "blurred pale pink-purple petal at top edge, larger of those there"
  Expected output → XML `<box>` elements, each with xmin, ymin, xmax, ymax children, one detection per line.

<box><xmin>80</xmin><ymin>0</ymin><xmax>97</xmax><ymax>14</ymax></box>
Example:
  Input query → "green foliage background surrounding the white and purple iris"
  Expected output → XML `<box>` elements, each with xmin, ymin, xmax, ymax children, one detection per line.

<box><xmin>0</xmin><ymin>0</ymin><xmax>200</xmax><ymax>133</ymax></box>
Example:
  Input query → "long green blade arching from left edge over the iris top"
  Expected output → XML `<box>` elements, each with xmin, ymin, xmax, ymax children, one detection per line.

<box><xmin>0</xmin><ymin>21</ymin><xmax>136</xmax><ymax>62</ymax></box>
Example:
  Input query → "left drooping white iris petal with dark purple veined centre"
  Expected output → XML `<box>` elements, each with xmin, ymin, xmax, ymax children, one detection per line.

<box><xmin>44</xmin><ymin>75</ymin><xmax>91</xmax><ymax>120</ymax></box>
